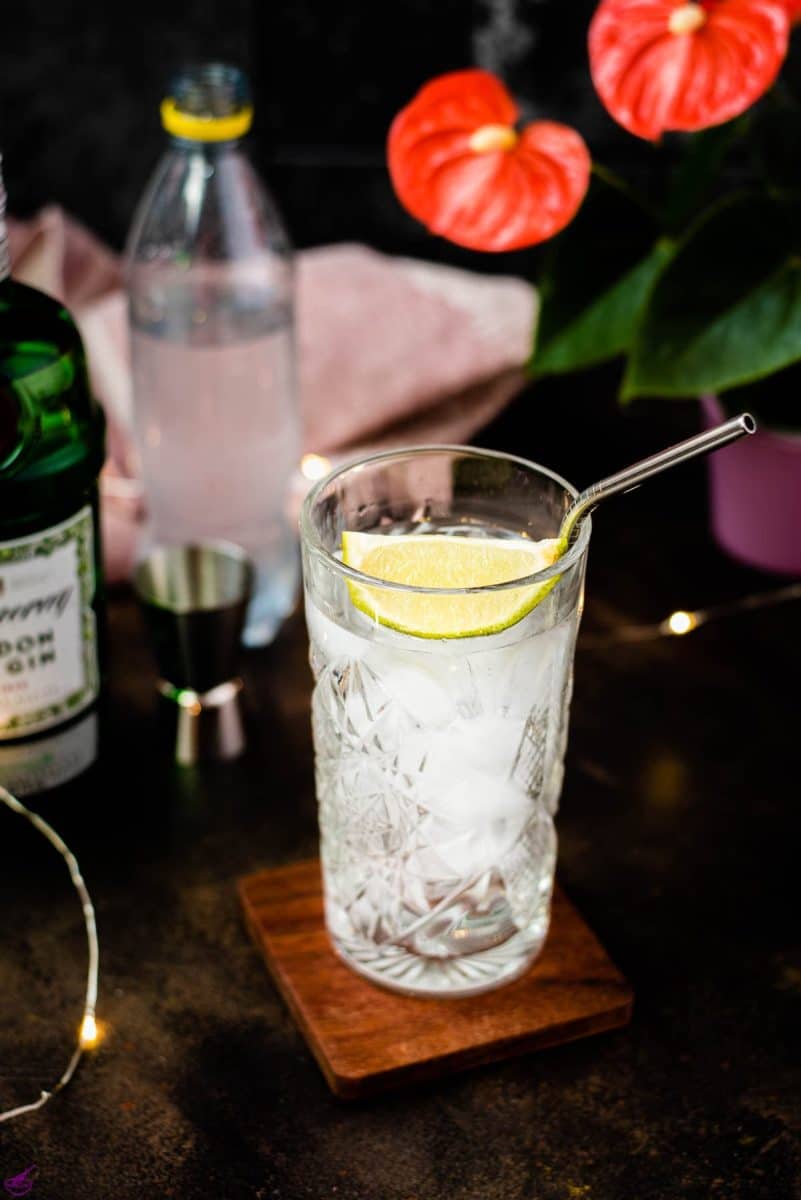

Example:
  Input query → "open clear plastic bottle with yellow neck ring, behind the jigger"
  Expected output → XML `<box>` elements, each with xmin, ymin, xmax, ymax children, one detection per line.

<box><xmin>126</xmin><ymin>62</ymin><xmax>300</xmax><ymax>646</ymax></box>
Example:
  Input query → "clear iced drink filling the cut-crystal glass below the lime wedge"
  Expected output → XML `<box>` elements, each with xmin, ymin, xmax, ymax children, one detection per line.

<box><xmin>306</xmin><ymin>527</ymin><xmax>578</xmax><ymax>996</ymax></box>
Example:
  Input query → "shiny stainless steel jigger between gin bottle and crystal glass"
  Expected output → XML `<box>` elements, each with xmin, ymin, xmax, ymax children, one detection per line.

<box><xmin>133</xmin><ymin>541</ymin><xmax>253</xmax><ymax>766</ymax></box>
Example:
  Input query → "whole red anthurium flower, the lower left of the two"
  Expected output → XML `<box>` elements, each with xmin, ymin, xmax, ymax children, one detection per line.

<box><xmin>387</xmin><ymin>70</ymin><xmax>591</xmax><ymax>251</ymax></box>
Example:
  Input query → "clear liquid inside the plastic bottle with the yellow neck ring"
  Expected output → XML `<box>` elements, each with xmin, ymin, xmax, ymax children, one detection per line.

<box><xmin>131</xmin><ymin>272</ymin><xmax>300</xmax><ymax>644</ymax></box>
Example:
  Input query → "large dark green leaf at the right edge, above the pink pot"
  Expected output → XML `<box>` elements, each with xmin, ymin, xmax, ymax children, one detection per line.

<box><xmin>622</xmin><ymin>194</ymin><xmax>801</xmax><ymax>400</ymax></box>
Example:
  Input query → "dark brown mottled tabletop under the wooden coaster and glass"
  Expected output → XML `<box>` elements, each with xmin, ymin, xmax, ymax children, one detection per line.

<box><xmin>0</xmin><ymin>386</ymin><xmax>801</xmax><ymax>1200</ymax></box>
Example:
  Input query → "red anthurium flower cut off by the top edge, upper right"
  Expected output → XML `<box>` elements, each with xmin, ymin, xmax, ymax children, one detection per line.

<box><xmin>590</xmin><ymin>0</ymin><xmax>786</xmax><ymax>140</ymax></box>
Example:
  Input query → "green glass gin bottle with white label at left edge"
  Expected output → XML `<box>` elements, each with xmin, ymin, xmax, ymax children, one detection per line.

<box><xmin>0</xmin><ymin>159</ymin><xmax>104</xmax><ymax>794</ymax></box>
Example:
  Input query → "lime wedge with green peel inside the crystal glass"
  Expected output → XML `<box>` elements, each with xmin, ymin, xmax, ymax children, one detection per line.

<box><xmin>342</xmin><ymin>530</ymin><xmax>565</xmax><ymax>637</ymax></box>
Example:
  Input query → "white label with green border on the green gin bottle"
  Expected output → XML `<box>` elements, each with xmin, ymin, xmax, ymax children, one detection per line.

<box><xmin>0</xmin><ymin>505</ymin><xmax>100</xmax><ymax>739</ymax></box>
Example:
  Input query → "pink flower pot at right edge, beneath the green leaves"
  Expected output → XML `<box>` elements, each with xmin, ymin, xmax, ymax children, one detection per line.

<box><xmin>700</xmin><ymin>396</ymin><xmax>801</xmax><ymax>575</ymax></box>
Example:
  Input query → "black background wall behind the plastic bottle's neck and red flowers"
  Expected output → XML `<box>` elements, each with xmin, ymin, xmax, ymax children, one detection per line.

<box><xmin>0</xmin><ymin>0</ymin><xmax>633</xmax><ymax>269</ymax></box>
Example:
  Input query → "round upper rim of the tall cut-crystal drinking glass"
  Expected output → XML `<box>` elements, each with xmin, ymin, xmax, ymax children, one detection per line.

<box><xmin>300</xmin><ymin>443</ymin><xmax>592</xmax><ymax>596</ymax></box>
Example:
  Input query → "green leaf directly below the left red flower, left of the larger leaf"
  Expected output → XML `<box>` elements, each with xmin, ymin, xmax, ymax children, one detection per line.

<box><xmin>528</xmin><ymin>178</ymin><xmax>670</xmax><ymax>377</ymax></box>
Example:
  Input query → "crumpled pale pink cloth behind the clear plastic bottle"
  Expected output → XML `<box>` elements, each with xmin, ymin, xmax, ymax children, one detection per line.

<box><xmin>10</xmin><ymin>206</ymin><xmax>537</xmax><ymax>581</ymax></box>
